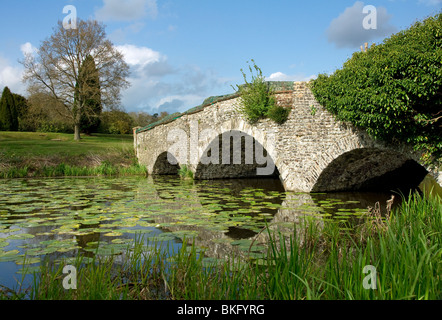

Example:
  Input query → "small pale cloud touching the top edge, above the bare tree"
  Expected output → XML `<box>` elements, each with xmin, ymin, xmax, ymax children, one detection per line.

<box><xmin>95</xmin><ymin>0</ymin><xmax>158</xmax><ymax>21</ymax></box>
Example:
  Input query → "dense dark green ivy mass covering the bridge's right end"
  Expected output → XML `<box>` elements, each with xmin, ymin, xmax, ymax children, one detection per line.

<box><xmin>312</xmin><ymin>13</ymin><xmax>442</xmax><ymax>164</ymax></box>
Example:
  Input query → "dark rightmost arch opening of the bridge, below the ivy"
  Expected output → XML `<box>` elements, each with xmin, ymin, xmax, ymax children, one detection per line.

<box><xmin>311</xmin><ymin>148</ymin><xmax>428</xmax><ymax>192</ymax></box>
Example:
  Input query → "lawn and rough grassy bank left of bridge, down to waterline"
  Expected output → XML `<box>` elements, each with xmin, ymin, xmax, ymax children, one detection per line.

<box><xmin>0</xmin><ymin>132</ymin><xmax>146</xmax><ymax>179</ymax></box>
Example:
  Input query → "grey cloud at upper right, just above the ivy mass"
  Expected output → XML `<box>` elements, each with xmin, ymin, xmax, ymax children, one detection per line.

<box><xmin>327</xmin><ymin>0</ymin><xmax>398</xmax><ymax>48</ymax></box>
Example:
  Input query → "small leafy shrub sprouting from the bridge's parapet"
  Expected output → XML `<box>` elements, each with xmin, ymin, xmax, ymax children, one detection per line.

<box><xmin>234</xmin><ymin>59</ymin><xmax>276</xmax><ymax>123</ymax></box>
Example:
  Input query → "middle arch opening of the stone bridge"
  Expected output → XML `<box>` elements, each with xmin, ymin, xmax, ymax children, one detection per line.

<box><xmin>194</xmin><ymin>129</ymin><xmax>279</xmax><ymax>179</ymax></box>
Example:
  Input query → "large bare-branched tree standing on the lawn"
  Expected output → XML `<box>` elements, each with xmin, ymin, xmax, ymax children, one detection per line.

<box><xmin>22</xmin><ymin>19</ymin><xmax>129</xmax><ymax>140</ymax></box>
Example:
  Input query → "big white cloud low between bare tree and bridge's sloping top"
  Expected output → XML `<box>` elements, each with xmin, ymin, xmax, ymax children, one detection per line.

<box><xmin>116</xmin><ymin>44</ymin><xmax>221</xmax><ymax>114</ymax></box>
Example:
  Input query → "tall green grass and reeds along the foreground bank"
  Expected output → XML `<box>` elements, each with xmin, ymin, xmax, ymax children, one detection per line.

<box><xmin>3</xmin><ymin>190</ymin><xmax>442</xmax><ymax>300</ymax></box>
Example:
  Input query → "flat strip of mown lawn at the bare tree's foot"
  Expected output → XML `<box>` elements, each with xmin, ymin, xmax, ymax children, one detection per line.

<box><xmin>0</xmin><ymin>132</ymin><xmax>133</xmax><ymax>156</ymax></box>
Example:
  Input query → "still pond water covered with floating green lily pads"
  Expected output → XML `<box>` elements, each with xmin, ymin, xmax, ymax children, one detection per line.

<box><xmin>0</xmin><ymin>177</ymin><xmax>398</xmax><ymax>288</ymax></box>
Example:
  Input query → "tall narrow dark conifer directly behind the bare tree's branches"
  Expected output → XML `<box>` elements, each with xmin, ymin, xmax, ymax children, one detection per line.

<box><xmin>77</xmin><ymin>55</ymin><xmax>103</xmax><ymax>134</ymax></box>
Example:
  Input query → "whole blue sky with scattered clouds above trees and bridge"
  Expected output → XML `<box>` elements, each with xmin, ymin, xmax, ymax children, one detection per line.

<box><xmin>0</xmin><ymin>0</ymin><xmax>442</xmax><ymax>113</ymax></box>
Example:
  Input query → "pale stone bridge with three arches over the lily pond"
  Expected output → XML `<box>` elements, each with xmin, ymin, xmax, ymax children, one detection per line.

<box><xmin>134</xmin><ymin>82</ymin><xmax>436</xmax><ymax>192</ymax></box>
